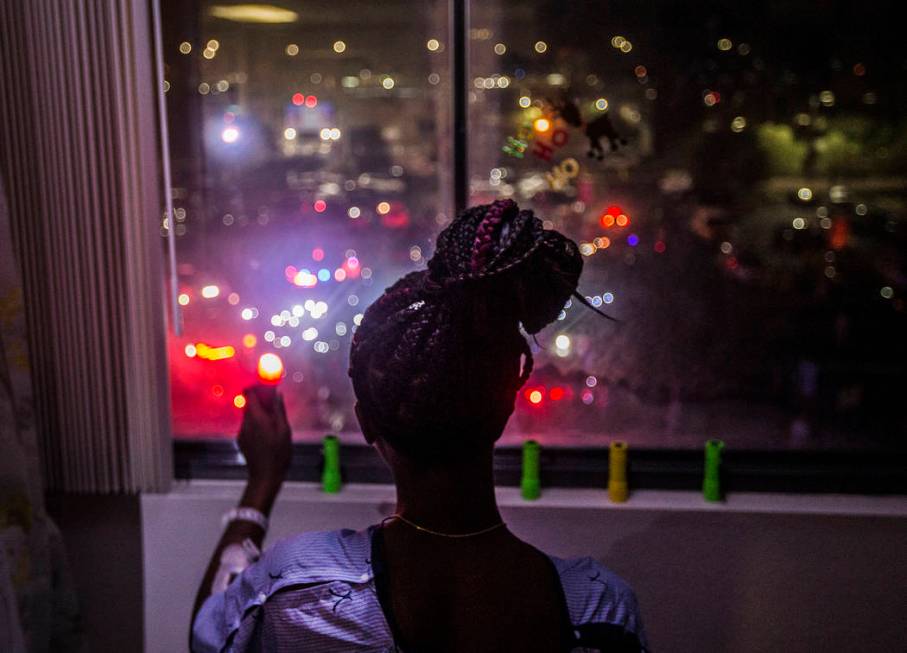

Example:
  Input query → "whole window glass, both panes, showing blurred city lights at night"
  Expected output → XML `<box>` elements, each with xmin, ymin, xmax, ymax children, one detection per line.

<box><xmin>161</xmin><ymin>0</ymin><xmax>907</xmax><ymax>468</ymax></box>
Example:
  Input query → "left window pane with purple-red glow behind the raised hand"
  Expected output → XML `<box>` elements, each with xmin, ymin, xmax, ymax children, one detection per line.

<box><xmin>161</xmin><ymin>0</ymin><xmax>451</xmax><ymax>439</ymax></box>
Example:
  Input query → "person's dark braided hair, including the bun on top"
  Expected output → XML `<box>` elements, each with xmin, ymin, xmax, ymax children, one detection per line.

<box><xmin>349</xmin><ymin>200</ymin><xmax>583</xmax><ymax>460</ymax></box>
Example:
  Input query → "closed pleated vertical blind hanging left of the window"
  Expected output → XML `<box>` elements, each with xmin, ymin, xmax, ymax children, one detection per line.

<box><xmin>0</xmin><ymin>0</ymin><xmax>172</xmax><ymax>492</ymax></box>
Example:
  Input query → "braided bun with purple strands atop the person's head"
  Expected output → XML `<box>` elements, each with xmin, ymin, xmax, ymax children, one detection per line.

<box><xmin>428</xmin><ymin>200</ymin><xmax>583</xmax><ymax>333</ymax></box>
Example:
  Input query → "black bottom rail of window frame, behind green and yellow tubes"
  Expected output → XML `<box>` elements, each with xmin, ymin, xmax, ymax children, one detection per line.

<box><xmin>174</xmin><ymin>440</ymin><xmax>907</xmax><ymax>495</ymax></box>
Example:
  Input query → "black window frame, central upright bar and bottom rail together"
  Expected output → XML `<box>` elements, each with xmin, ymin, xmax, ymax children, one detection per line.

<box><xmin>165</xmin><ymin>0</ymin><xmax>907</xmax><ymax>495</ymax></box>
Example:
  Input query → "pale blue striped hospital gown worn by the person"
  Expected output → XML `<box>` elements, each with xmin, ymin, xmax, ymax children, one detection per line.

<box><xmin>192</xmin><ymin>526</ymin><xmax>648</xmax><ymax>653</ymax></box>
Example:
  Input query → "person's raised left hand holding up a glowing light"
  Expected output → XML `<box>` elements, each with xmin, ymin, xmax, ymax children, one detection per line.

<box><xmin>237</xmin><ymin>385</ymin><xmax>292</xmax><ymax>489</ymax></box>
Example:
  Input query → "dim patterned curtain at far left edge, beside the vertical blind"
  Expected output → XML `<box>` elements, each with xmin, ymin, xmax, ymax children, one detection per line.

<box><xmin>0</xmin><ymin>177</ymin><xmax>80</xmax><ymax>653</ymax></box>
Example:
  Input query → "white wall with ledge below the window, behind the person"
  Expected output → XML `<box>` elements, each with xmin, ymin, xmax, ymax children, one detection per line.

<box><xmin>141</xmin><ymin>482</ymin><xmax>907</xmax><ymax>653</ymax></box>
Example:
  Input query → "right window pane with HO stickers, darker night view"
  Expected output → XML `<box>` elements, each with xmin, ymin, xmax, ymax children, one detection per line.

<box><xmin>469</xmin><ymin>0</ymin><xmax>907</xmax><ymax>449</ymax></box>
